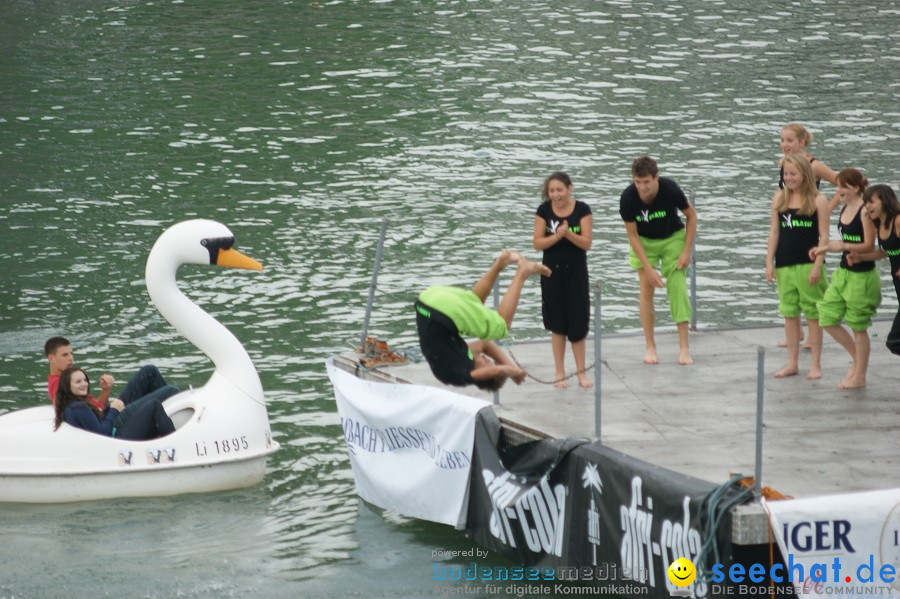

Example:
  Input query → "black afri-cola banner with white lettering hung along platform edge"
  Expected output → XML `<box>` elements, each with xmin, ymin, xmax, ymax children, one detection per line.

<box><xmin>466</xmin><ymin>408</ymin><xmax>731</xmax><ymax>598</ymax></box>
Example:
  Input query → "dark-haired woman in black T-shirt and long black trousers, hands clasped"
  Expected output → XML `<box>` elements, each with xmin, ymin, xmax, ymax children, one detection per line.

<box><xmin>532</xmin><ymin>172</ymin><xmax>594</xmax><ymax>389</ymax></box>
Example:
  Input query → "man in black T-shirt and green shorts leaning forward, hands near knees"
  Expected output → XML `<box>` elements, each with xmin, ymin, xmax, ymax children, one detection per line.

<box><xmin>619</xmin><ymin>156</ymin><xmax>697</xmax><ymax>365</ymax></box>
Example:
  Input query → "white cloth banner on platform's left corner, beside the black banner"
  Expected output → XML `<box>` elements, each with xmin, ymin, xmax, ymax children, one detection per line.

<box><xmin>326</xmin><ymin>359</ymin><xmax>488</xmax><ymax>528</ymax></box>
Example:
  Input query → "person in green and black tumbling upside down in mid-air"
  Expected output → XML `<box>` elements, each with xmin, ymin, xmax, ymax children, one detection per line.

<box><xmin>415</xmin><ymin>251</ymin><xmax>550</xmax><ymax>391</ymax></box>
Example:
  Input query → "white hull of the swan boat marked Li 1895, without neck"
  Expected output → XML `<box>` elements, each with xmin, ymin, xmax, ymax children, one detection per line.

<box><xmin>0</xmin><ymin>375</ymin><xmax>279</xmax><ymax>503</ymax></box>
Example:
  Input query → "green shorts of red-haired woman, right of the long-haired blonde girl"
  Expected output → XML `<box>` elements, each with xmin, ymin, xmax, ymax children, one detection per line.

<box><xmin>819</xmin><ymin>268</ymin><xmax>881</xmax><ymax>331</ymax></box>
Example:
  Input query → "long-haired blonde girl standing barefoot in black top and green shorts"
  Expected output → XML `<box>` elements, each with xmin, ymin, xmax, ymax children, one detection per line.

<box><xmin>766</xmin><ymin>154</ymin><xmax>830</xmax><ymax>380</ymax></box>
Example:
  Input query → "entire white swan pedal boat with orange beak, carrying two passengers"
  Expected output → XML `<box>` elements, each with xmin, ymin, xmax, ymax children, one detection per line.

<box><xmin>0</xmin><ymin>220</ymin><xmax>279</xmax><ymax>503</ymax></box>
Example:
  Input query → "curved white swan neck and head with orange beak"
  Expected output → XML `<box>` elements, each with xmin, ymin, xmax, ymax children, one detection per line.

<box><xmin>145</xmin><ymin>219</ymin><xmax>265</xmax><ymax>406</ymax></box>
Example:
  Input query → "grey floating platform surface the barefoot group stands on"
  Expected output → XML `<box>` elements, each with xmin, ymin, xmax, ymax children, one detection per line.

<box><xmin>340</xmin><ymin>320</ymin><xmax>900</xmax><ymax>543</ymax></box>
